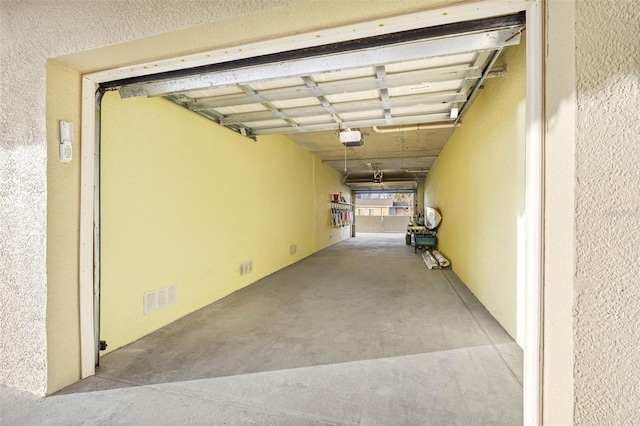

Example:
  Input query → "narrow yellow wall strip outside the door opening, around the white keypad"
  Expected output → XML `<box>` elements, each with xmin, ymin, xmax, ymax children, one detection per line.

<box><xmin>46</xmin><ymin>61</ymin><xmax>80</xmax><ymax>390</ymax></box>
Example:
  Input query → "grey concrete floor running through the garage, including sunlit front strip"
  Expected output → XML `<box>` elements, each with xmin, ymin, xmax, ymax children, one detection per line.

<box><xmin>0</xmin><ymin>234</ymin><xmax>522</xmax><ymax>426</ymax></box>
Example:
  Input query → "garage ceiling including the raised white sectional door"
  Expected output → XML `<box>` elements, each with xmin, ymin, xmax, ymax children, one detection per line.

<box><xmin>120</xmin><ymin>15</ymin><xmax>524</xmax><ymax>189</ymax></box>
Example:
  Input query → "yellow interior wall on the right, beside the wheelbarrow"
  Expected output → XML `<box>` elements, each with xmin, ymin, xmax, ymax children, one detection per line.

<box><xmin>425</xmin><ymin>39</ymin><xmax>525</xmax><ymax>340</ymax></box>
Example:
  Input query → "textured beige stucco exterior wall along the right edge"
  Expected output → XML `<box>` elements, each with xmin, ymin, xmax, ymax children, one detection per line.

<box><xmin>574</xmin><ymin>0</ymin><xmax>640</xmax><ymax>425</ymax></box>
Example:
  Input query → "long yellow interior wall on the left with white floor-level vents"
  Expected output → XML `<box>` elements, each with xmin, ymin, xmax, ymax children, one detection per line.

<box><xmin>101</xmin><ymin>92</ymin><xmax>349</xmax><ymax>351</ymax></box>
